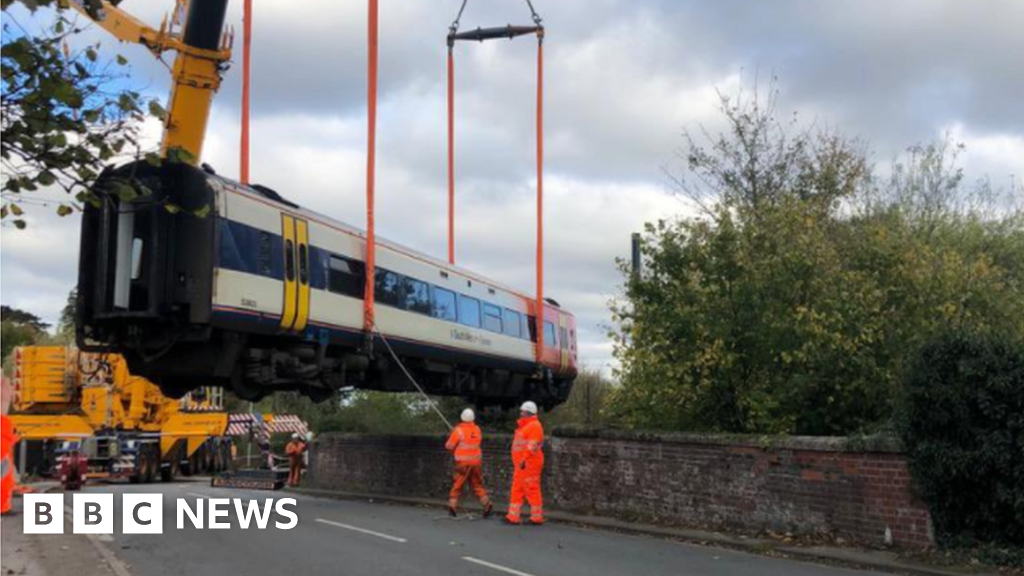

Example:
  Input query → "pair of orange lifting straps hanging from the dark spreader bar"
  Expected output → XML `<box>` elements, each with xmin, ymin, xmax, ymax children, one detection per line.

<box><xmin>447</xmin><ymin>0</ymin><xmax>544</xmax><ymax>363</ymax></box>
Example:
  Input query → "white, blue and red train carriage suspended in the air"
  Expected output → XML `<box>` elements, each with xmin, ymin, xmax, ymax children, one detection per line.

<box><xmin>78</xmin><ymin>158</ymin><xmax>577</xmax><ymax>406</ymax></box>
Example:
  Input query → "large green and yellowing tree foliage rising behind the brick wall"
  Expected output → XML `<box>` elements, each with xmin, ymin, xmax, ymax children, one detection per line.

<box><xmin>611</xmin><ymin>86</ymin><xmax>1024</xmax><ymax>435</ymax></box>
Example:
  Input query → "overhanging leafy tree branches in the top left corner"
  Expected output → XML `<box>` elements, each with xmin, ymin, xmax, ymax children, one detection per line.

<box><xmin>0</xmin><ymin>0</ymin><xmax>164</xmax><ymax>229</ymax></box>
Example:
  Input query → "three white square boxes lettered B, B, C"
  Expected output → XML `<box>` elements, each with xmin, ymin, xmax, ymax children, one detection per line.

<box><xmin>23</xmin><ymin>494</ymin><xmax>164</xmax><ymax>534</ymax></box>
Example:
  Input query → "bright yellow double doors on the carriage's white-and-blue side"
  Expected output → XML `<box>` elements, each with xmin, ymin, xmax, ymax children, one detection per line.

<box><xmin>281</xmin><ymin>214</ymin><xmax>309</xmax><ymax>332</ymax></box>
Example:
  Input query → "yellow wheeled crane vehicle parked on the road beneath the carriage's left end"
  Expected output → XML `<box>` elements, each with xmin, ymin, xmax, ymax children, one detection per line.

<box><xmin>10</xmin><ymin>346</ymin><xmax>230</xmax><ymax>482</ymax></box>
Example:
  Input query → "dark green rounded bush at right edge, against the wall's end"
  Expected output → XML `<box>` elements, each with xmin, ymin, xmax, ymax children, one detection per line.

<box><xmin>898</xmin><ymin>334</ymin><xmax>1024</xmax><ymax>544</ymax></box>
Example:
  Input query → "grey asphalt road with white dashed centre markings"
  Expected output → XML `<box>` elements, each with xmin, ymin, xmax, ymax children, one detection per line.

<box><xmin>36</xmin><ymin>482</ymin><xmax>878</xmax><ymax>576</ymax></box>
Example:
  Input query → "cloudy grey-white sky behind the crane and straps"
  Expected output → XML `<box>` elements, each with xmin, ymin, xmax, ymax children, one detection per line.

<box><xmin>0</xmin><ymin>0</ymin><xmax>1024</xmax><ymax>367</ymax></box>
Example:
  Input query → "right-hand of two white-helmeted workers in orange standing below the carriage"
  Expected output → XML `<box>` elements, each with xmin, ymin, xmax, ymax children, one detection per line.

<box><xmin>505</xmin><ymin>402</ymin><xmax>544</xmax><ymax>525</ymax></box>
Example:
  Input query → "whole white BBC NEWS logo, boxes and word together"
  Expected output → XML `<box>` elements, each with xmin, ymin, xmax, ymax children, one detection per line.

<box><xmin>23</xmin><ymin>494</ymin><xmax>299</xmax><ymax>534</ymax></box>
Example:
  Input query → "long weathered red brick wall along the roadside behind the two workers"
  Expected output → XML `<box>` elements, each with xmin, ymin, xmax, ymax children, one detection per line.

<box><xmin>310</xmin><ymin>429</ymin><xmax>932</xmax><ymax>547</ymax></box>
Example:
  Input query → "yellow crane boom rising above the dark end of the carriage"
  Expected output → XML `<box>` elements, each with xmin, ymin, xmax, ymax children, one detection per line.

<box><xmin>60</xmin><ymin>0</ymin><xmax>232</xmax><ymax>164</ymax></box>
